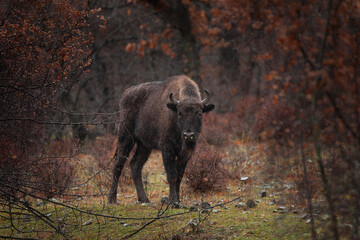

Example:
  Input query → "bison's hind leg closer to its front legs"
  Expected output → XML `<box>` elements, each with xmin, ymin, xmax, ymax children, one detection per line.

<box><xmin>130</xmin><ymin>143</ymin><xmax>151</xmax><ymax>203</ymax></box>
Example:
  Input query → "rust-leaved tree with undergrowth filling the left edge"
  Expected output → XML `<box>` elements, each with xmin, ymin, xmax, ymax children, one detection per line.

<box><xmin>0</xmin><ymin>0</ymin><xmax>104</xmax><ymax>235</ymax></box>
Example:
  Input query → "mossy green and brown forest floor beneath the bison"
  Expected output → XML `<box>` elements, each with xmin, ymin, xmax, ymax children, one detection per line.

<box><xmin>0</xmin><ymin>141</ymin><xmax>311</xmax><ymax>239</ymax></box>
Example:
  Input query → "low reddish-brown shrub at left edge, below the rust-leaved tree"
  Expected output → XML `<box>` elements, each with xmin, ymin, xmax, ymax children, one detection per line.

<box><xmin>0</xmin><ymin>136</ymin><xmax>76</xmax><ymax>199</ymax></box>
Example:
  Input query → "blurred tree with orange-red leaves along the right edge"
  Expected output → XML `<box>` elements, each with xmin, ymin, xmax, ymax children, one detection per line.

<box><xmin>245</xmin><ymin>0</ymin><xmax>360</xmax><ymax>239</ymax></box>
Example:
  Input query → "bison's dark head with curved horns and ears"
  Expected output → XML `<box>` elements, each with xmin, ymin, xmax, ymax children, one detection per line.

<box><xmin>167</xmin><ymin>90</ymin><xmax>215</xmax><ymax>145</ymax></box>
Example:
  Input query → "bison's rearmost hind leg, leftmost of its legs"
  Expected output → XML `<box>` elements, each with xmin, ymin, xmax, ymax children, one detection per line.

<box><xmin>109</xmin><ymin>137</ymin><xmax>134</xmax><ymax>204</ymax></box>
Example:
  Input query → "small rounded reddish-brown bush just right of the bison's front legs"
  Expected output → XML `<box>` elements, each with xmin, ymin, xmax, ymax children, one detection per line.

<box><xmin>185</xmin><ymin>143</ymin><xmax>229</xmax><ymax>193</ymax></box>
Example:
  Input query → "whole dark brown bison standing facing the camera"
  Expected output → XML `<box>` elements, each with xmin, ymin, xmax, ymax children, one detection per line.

<box><xmin>109</xmin><ymin>75</ymin><xmax>214</xmax><ymax>203</ymax></box>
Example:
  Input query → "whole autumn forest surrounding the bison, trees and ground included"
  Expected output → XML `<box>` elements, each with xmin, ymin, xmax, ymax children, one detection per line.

<box><xmin>0</xmin><ymin>0</ymin><xmax>360</xmax><ymax>240</ymax></box>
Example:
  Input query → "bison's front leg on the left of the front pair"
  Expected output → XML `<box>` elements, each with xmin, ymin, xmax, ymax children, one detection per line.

<box><xmin>162</xmin><ymin>150</ymin><xmax>179</xmax><ymax>203</ymax></box>
